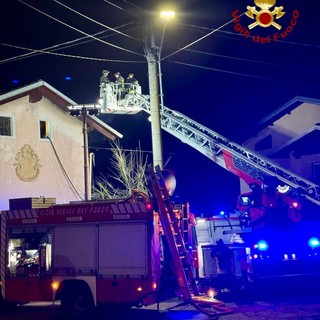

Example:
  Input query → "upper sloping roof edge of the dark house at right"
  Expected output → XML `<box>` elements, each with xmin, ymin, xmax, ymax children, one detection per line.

<box><xmin>240</xmin><ymin>96</ymin><xmax>320</xmax><ymax>141</ymax></box>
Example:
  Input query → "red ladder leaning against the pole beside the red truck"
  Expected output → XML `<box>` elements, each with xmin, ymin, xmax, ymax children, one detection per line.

<box><xmin>147</xmin><ymin>165</ymin><xmax>233</xmax><ymax>319</ymax></box>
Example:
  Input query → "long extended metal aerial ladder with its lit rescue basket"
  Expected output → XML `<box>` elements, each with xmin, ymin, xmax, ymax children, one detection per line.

<box><xmin>100</xmin><ymin>84</ymin><xmax>320</xmax><ymax>205</ymax></box>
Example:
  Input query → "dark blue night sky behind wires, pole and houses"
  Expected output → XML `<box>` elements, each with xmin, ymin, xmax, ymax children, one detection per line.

<box><xmin>0</xmin><ymin>0</ymin><xmax>320</xmax><ymax>215</ymax></box>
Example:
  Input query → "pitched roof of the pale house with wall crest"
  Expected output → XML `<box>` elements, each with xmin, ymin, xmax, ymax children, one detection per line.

<box><xmin>0</xmin><ymin>80</ymin><xmax>123</xmax><ymax>140</ymax></box>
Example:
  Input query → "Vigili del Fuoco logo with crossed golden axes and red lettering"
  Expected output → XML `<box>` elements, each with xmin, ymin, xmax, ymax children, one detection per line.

<box><xmin>232</xmin><ymin>0</ymin><xmax>299</xmax><ymax>43</ymax></box>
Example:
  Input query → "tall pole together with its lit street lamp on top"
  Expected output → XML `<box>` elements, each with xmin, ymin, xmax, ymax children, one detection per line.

<box><xmin>144</xmin><ymin>11</ymin><xmax>175</xmax><ymax>168</ymax></box>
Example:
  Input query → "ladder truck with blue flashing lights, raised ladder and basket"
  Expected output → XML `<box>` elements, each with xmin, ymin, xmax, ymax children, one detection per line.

<box><xmin>100</xmin><ymin>84</ymin><xmax>320</xmax><ymax>279</ymax></box>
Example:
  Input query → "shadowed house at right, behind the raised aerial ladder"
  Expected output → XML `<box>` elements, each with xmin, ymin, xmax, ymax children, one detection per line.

<box><xmin>242</xmin><ymin>97</ymin><xmax>320</xmax><ymax>190</ymax></box>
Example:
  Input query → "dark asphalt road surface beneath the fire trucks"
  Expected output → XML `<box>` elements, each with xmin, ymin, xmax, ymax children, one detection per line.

<box><xmin>0</xmin><ymin>295</ymin><xmax>320</xmax><ymax>320</ymax></box>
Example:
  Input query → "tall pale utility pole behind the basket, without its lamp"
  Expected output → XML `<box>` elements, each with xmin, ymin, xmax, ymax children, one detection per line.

<box><xmin>144</xmin><ymin>25</ymin><xmax>163</xmax><ymax>168</ymax></box>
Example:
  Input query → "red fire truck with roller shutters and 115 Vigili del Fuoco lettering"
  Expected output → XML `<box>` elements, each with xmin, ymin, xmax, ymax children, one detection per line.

<box><xmin>0</xmin><ymin>199</ymin><xmax>160</xmax><ymax>314</ymax></box>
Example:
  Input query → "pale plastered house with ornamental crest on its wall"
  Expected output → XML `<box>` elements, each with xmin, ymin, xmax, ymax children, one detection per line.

<box><xmin>0</xmin><ymin>80</ymin><xmax>122</xmax><ymax>209</ymax></box>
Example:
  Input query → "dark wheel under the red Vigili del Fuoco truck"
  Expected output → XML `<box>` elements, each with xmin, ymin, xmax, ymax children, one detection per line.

<box><xmin>61</xmin><ymin>286</ymin><xmax>94</xmax><ymax>319</ymax></box>
